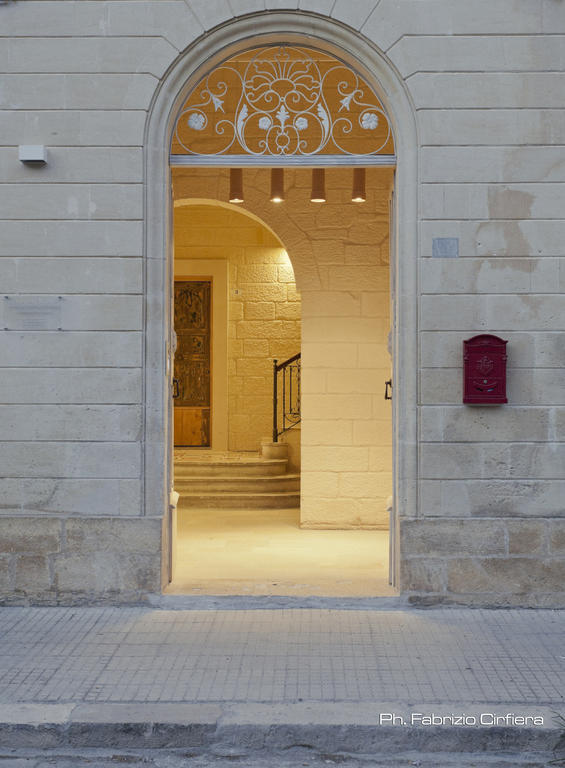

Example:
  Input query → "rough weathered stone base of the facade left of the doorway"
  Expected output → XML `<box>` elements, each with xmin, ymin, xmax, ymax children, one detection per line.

<box><xmin>0</xmin><ymin>510</ymin><xmax>161</xmax><ymax>605</ymax></box>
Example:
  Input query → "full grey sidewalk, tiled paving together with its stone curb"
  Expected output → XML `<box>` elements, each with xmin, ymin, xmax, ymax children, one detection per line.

<box><xmin>0</xmin><ymin>601</ymin><xmax>565</xmax><ymax>764</ymax></box>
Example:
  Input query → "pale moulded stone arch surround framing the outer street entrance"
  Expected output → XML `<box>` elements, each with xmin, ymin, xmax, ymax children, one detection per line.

<box><xmin>144</xmin><ymin>11</ymin><xmax>418</xmax><ymax>588</ymax></box>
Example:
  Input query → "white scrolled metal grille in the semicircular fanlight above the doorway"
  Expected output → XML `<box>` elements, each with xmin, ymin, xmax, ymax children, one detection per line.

<box><xmin>171</xmin><ymin>45</ymin><xmax>394</xmax><ymax>162</ymax></box>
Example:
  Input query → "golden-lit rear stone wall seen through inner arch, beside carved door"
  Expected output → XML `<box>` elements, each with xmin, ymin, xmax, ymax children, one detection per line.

<box><xmin>174</xmin><ymin>204</ymin><xmax>300</xmax><ymax>451</ymax></box>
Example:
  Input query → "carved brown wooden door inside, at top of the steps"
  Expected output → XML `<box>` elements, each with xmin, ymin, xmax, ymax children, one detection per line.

<box><xmin>174</xmin><ymin>280</ymin><xmax>212</xmax><ymax>447</ymax></box>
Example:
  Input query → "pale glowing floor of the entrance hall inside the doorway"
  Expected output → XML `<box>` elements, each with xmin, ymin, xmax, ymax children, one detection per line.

<box><xmin>166</xmin><ymin>498</ymin><xmax>396</xmax><ymax>597</ymax></box>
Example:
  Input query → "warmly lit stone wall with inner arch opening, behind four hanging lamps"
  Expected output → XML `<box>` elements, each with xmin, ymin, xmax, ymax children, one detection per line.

<box><xmin>173</xmin><ymin>168</ymin><xmax>393</xmax><ymax>528</ymax></box>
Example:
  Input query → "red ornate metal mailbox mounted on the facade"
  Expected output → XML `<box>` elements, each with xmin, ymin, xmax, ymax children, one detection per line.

<box><xmin>463</xmin><ymin>333</ymin><xmax>508</xmax><ymax>405</ymax></box>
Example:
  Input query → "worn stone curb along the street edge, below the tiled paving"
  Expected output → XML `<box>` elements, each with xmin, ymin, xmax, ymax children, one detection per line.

<box><xmin>0</xmin><ymin>701</ymin><xmax>565</xmax><ymax>755</ymax></box>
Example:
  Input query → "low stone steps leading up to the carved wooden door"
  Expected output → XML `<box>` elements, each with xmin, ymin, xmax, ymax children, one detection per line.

<box><xmin>174</xmin><ymin>449</ymin><xmax>300</xmax><ymax>509</ymax></box>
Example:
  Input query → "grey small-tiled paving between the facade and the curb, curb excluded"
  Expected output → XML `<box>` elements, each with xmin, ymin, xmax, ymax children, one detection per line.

<box><xmin>0</xmin><ymin>607</ymin><xmax>565</xmax><ymax>711</ymax></box>
